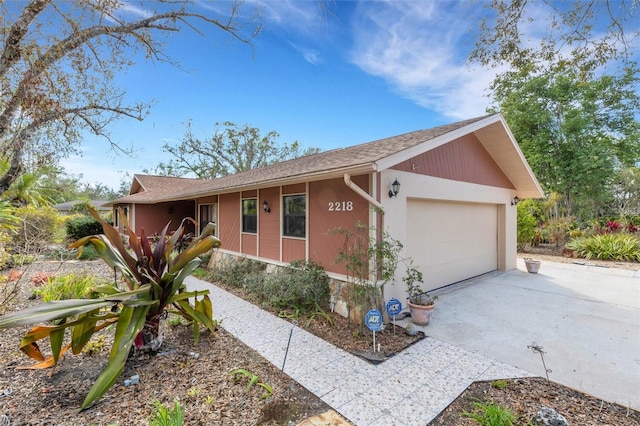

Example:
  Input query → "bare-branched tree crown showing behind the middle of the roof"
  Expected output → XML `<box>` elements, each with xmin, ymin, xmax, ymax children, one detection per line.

<box><xmin>145</xmin><ymin>121</ymin><xmax>320</xmax><ymax>179</ymax></box>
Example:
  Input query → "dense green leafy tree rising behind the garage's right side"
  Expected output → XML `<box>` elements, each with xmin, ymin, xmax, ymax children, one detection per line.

<box><xmin>492</xmin><ymin>62</ymin><xmax>640</xmax><ymax>221</ymax></box>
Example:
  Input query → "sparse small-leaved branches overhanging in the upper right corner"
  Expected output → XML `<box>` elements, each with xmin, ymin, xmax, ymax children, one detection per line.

<box><xmin>470</xmin><ymin>0</ymin><xmax>640</xmax><ymax>73</ymax></box>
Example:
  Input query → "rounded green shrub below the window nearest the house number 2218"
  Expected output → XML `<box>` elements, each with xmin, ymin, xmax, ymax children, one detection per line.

<box><xmin>262</xmin><ymin>261</ymin><xmax>329</xmax><ymax>312</ymax></box>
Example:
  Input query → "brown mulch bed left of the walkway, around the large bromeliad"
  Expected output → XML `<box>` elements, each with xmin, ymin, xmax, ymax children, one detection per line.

<box><xmin>0</xmin><ymin>260</ymin><xmax>330</xmax><ymax>426</ymax></box>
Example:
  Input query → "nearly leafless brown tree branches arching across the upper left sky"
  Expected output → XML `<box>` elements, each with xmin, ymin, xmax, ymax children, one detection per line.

<box><xmin>0</xmin><ymin>0</ymin><xmax>261</xmax><ymax>192</ymax></box>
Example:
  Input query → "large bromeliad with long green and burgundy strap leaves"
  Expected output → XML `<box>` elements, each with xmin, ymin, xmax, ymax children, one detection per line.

<box><xmin>0</xmin><ymin>210</ymin><xmax>221</xmax><ymax>410</ymax></box>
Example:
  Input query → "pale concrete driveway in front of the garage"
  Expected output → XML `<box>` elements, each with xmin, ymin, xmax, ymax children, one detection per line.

<box><xmin>410</xmin><ymin>259</ymin><xmax>640</xmax><ymax>409</ymax></box>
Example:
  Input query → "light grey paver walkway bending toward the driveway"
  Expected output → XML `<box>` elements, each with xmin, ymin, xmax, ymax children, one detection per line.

<box><xmin>185</xmin><ymin>277</ymin><xmax>533</xmax><ymax>426</ymax></box>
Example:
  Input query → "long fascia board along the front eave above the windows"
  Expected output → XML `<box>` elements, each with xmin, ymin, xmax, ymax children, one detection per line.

<box><xmin>156</xmin><ymin>163</ymin><xmax>375</xmax><ymax>204</ymax></box>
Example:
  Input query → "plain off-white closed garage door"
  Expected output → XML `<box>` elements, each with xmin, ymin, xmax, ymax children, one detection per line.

<box><xmin>406</xmin><ymin>200</ymin><xmax>498</xmax><ymax>290</ymax></box>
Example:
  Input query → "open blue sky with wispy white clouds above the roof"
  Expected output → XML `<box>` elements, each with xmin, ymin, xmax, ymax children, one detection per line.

<box><xmin>55</xmin><ymin>0</ymin><xmax>636</xmax><ymax>188</ymax></box>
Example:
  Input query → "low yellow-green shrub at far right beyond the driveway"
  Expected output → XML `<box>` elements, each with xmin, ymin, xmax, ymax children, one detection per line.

<box><xmin>567</xmin><ymin>233</ymin><xmax>640</xmax><ymax>262</ymax></box>
